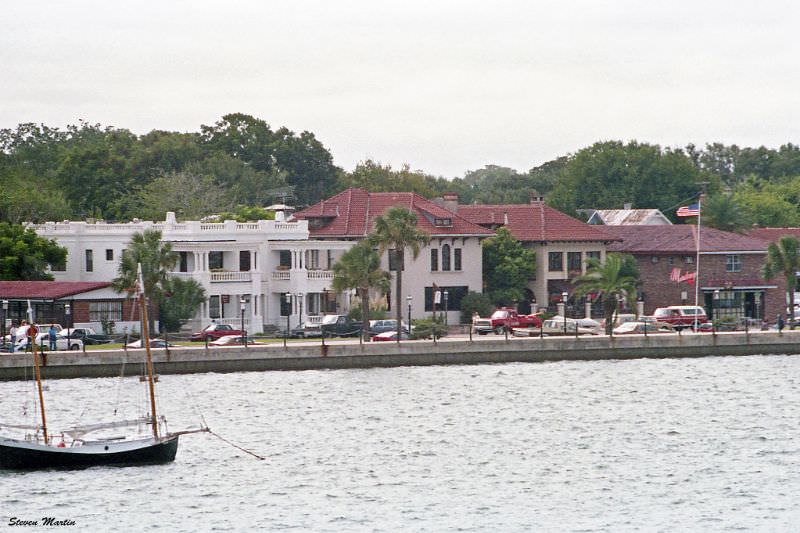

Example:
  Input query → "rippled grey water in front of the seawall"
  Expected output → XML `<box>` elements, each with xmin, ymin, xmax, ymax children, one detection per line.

<box><xmin>0</xmin><ymin>356</ymin><xmax>800</xmax><ymax>532</ymax></box>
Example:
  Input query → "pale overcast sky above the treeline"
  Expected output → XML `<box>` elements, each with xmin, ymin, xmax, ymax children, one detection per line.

<box><xmin>0</xmin><ymin>0</ymin><xmax>800</xmax><ymax>177</ymax></box>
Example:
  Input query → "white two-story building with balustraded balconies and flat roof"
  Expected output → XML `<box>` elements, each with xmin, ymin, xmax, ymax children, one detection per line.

<box><xmin>32</xmin><ymin>212</ymin><xmax>353</xmax><ymax>333</ymax></box>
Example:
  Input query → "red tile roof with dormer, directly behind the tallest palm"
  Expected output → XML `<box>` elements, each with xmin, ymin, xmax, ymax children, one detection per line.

<box><xmin>294</xmin><ymin>189</ymin><xmax>494</xmax><ymax>238</ymax></box>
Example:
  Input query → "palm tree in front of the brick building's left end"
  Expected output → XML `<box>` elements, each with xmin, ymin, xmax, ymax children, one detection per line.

<box><xmin>573</xmin><ymin>253</ymin><xmax>639</xmax><ymax>335</ymax></box>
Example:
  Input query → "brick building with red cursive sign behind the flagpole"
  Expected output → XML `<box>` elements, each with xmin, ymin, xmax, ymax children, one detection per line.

<box><xmin>603</xmin><ymin>224</ymin><xmax>786</xmax><ymax>322</ymax></box>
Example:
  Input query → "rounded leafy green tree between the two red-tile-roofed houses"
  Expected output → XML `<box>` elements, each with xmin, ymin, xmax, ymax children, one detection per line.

<box><xmin>482</xmin><ymin>227</ymin><xmax>536</xmax><ymax>305</ymax></box>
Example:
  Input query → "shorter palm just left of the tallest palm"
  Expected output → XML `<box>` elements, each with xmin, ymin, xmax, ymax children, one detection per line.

<box><xmin>333</xmin><ymin>241</ymin><xmax>390</xmax><ymax>340</ymax></box>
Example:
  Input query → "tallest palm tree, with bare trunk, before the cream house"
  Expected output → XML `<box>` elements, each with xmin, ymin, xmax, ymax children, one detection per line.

<box><xmin>368</xmin><ymin>207</ymin><xmax>431</xmax><ymax>342</ymax></box>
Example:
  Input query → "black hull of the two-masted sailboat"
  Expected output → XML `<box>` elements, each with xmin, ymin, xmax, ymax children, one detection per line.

<box><xmin>0</xmin><ymin>435</ymin><xmax>178</xmax><ymax>470</ymax></box>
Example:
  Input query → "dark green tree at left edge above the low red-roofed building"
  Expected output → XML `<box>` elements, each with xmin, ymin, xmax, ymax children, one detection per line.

<box><xmin>0</xmin><ymin>222</ymin><xmax>67</xmax><ymax>281</ymax></box>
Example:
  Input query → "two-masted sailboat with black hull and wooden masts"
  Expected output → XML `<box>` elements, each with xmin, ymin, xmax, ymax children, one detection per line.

<box><xmin>0</xmin><ymin>265</ymin><xmax>190</xmax><ymax>470</ymax></box>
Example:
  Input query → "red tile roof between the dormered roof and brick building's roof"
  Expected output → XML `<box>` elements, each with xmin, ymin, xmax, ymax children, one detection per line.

<box><xmin>458</xmin><ymin>202</ymin><xmax>615</xmax><ymax>242</ymax></box>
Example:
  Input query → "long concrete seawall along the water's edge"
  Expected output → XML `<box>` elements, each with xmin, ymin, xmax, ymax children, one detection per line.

<box><xmin>0</xmin><ymin>330</ymin><xmax>800</xmax><ymax>381</ymax></box>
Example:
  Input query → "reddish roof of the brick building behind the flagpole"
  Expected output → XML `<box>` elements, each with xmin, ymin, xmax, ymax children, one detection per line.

<box><xmin>603</xmin><ymin>224</ymin><xmax>767</xmax><ymax>251</ymax></box>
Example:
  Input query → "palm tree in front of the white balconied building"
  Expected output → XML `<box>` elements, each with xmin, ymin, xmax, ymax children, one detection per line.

<box><xmin>111</xmin><ymin>229</ymin><xmax>178</xmax><ymax>331</ymax></box>
